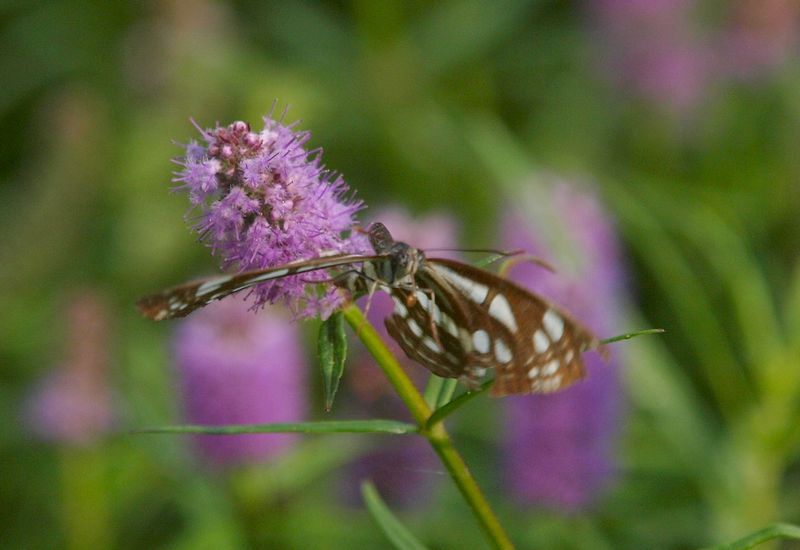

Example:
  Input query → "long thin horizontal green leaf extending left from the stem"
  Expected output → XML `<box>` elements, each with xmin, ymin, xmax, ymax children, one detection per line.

<box><xmin>133</xmin><ymin>420</ymin><xmax>417</xmax><ymax>435</ymax></box>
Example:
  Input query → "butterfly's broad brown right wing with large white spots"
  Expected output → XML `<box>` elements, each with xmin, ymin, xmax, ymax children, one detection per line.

<box><xmin>387</xmin><ymin>259</ymin><xmax>599</xmax><ymax>396</ymax></box>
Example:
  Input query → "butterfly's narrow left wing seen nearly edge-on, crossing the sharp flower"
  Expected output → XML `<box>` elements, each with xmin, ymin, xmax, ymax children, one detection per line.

<box><xmin>136</xmin><ymin>254</ymin><xmax>382</xmax><ymax>321</ymax></box>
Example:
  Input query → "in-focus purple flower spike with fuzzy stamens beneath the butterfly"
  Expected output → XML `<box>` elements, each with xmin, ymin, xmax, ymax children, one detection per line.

<box><xmin>173</xmin><ymin>112</ymin><xmax>369</xmax><ymax>317</ymax></box>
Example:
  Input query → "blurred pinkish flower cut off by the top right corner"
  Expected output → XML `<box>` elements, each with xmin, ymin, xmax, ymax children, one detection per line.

<box><xmin>719</xmin><ymin>0</ymin><xmax>800</xmax><ymax>79</ymax></box>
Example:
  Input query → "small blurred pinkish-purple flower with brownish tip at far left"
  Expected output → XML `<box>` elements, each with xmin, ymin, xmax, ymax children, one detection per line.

<box><xmin>25</xmin><ymin>291</ymin><xmax>114</xmax><ymax>446</ymax></box>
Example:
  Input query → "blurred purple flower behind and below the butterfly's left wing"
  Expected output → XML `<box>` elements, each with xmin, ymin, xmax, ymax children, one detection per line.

<box><xmin>174</xmin><ymin>297</ymin><xmax>306</xmax><ymax>466</ymax></box>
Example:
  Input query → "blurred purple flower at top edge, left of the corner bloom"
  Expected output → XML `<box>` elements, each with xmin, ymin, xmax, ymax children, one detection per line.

<box><xmin>590</xmin><ymin>0</ymin><xmax>713</xmax><ymax>114</ymax></box>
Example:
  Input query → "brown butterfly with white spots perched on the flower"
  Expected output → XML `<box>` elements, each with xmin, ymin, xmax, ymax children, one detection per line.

<box><xmin>137</xmin><ymin>223</ymin><xmax>600</xmax><ymax>397</ymax></box>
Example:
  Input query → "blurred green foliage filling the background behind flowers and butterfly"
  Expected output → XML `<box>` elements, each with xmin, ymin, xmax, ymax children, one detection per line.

<box><xmin>0</xmin><ymin>0</ymin><xmax>800</xmax><ymax>548</ymax></box>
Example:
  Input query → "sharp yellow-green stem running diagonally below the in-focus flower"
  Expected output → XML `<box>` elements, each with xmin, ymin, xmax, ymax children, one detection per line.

<box><xmin>344</xmin><ymin>305</ymin><xmax>514</xmax><ymax>548</ymax></box>
